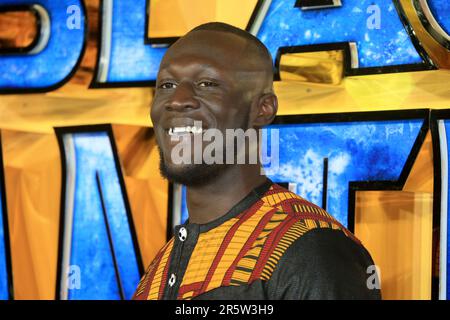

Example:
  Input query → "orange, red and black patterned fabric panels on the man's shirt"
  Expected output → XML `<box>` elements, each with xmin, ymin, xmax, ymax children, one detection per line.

<box><xmin>135</xmin><ymin>184</ymin><xmax>358</xmax><ymax>300</ymax></box>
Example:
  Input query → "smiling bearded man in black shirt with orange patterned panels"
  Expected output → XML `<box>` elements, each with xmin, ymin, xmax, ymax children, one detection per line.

<box><xmin>134</xmin><ymin>23</ymin><xmax>380</xmax><ymax>300</ymax></box>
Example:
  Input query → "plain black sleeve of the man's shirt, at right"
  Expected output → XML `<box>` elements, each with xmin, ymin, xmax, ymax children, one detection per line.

<box><xmin>268</xmin><ymin>229</ymin><xmax>381</xmax><ymax>300</ymax></box>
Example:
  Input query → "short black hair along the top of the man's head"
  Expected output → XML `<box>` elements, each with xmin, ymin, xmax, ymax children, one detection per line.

<box><xmin>188</xmin><ymin>22</ymin><xmax>273</xmax><ymax>64</ymax></box>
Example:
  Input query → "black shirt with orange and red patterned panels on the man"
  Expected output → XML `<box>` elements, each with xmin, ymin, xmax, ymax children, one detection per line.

<box><xmin>133</xmin><ymin>179</ymin><xmax>381</xmax><ymax>300</ymax></box>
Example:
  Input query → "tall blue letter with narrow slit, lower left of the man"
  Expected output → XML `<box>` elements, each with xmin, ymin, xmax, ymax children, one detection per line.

<box><xmin>69</xmin><ymin>132</ymin><xmax>140</xmax><ymax>300</ymax></box>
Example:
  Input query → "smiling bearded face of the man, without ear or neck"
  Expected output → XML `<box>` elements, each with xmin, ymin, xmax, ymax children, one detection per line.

<box><xmin>151</xmin><ymin>31</ymin><xmax>261</xmax><ymax>185</ymax></box>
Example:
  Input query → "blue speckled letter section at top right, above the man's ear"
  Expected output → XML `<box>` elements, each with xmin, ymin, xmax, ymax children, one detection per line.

<box><xmin>258</xmin><ymin>0</ymin><xmax>422</xmax><ymax>67</ymax></box>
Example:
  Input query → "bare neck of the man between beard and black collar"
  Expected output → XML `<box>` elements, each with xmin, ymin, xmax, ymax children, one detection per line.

<box><xmin>186</xmin><ymin>165</ymin><xmax>266</xmax><ymax>224</ymax></box>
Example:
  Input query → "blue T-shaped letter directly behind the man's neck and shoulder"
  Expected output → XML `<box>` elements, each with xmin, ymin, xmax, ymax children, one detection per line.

<box><xmin>267</xmin><ymin>119</ymin><xmax>423</xmax><ymax>226</ymax></box>
